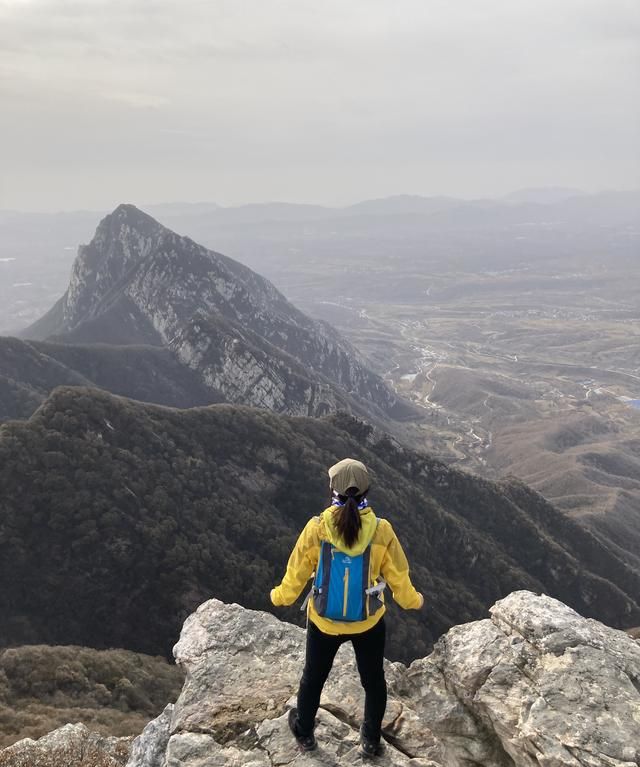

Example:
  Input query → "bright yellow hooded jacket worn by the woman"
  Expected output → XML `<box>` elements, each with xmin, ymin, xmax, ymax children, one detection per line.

<box><xmin>271</xmin><ymin>506</ymin><xmax>424</xmax><ymax>634</ymax></box>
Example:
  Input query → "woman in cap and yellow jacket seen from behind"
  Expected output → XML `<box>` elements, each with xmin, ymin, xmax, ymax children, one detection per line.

<box><xmin>271</xmin><ymin>458</ymin><xmax>424</xmax><ymax>756</ymax></box>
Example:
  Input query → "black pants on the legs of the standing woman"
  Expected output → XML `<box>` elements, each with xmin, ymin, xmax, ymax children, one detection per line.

<box><xmin>297</xmin><ymin>618</ymin><xmax>387</xmax><ymax>742</ymax></box>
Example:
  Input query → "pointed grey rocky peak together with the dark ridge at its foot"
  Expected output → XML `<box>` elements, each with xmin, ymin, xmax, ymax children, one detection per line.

<box><xmin>5</xmin><ymin>205</ymin><xmax>413</xmax><ymax>419</ymax></box>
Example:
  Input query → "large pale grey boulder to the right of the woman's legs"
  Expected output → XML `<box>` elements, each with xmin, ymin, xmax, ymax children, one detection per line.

<box><xmin>402</xmin><ymin>591</ymin><xmax>640</xmax><ymax>767</ymax></box>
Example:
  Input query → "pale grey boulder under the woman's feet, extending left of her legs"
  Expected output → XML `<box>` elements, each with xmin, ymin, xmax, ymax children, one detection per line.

<box><xmin>168</xmin><ymin>599</ymin><xmax>439</xmax><ymax>767</ymax></box>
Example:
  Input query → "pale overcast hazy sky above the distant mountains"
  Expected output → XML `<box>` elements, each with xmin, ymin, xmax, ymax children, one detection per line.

<box><xmin>0</xmin><ymin>0</ymin><xmax>640</xmax><ymax>210</ymax></box>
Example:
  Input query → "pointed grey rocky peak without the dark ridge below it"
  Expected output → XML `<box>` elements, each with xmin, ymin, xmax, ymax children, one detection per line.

<box><xmin>24</xmin><ymin>205</ymin><xmax>398</xmax><ymax>415</ymax></box>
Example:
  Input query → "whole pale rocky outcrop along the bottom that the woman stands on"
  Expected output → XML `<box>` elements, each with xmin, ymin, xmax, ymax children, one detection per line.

<box><xmin>0</xmin><ymin>591</ymin><xmax>640</xmax><ymax>767</ymax></box>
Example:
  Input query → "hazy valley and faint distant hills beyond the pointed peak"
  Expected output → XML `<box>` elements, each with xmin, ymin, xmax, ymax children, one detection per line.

<box><xmin>0</xmin><ymin>193</ymin><xmax>640</xmax><ymax>565</ymax></box>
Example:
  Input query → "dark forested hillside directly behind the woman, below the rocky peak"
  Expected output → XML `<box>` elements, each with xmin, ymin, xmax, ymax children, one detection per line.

<box><xmin>0</xmin><ymin>388</ymin><xmax>640</xmax><ymax>660</ymax></box>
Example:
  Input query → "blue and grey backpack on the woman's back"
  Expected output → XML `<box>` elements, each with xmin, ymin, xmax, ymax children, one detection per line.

<box><xmin>303</xmin><ymin>519</ymin><xmax>386</xmax><ymax>623</ymax></box>
